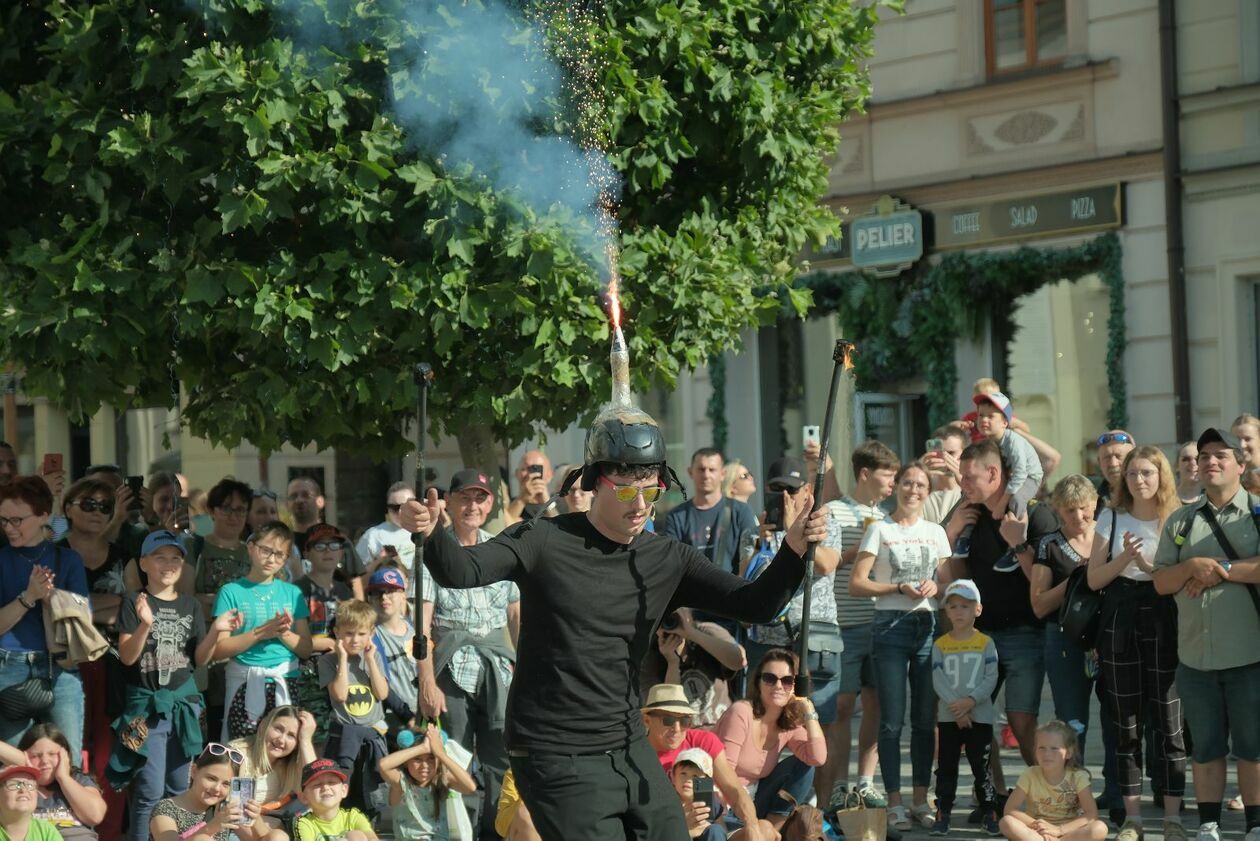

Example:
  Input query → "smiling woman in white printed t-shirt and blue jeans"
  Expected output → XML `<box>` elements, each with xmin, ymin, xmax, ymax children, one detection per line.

<box><xmin>849</xmin><ymin>461</ymin><xmax>950</xmax><ymax>830</ymax></box>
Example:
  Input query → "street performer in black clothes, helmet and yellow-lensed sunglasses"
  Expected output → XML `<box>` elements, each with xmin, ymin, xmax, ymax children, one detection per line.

<box><xmin>401</xmin><ymin>415</ymin><xmax>827</xmax><ymax>841</ymax></box>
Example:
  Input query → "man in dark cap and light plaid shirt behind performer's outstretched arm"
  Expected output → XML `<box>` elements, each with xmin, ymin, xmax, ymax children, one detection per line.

<box><xmin>420</xmin><ymin>468</ymin><xmax>520</xmax><ymax>838</ymax></box>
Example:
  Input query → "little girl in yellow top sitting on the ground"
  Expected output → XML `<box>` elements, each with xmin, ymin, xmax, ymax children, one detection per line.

<box><xmin>1000</xmin><ymin>721</ymin><xmax>1108</xmax><ymax>841</ymax></box>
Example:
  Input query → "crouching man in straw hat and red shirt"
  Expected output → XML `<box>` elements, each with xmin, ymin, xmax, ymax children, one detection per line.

<box><xmin>641</xmin><ymin>683</ymin><xmax>774</xmax><ymax>837</ymax></box>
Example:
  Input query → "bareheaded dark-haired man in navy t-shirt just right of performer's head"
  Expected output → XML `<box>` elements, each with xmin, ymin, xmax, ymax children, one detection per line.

<box><xmin>660</xmin><ymin>446</ymin><xmax>757</xmax><ymax>572</ymax></box>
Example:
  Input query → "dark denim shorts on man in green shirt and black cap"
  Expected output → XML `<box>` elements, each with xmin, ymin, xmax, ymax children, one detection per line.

<box><xmin>1177</xmin><ymin>663</ymin><xmax>1260</xmax><ymax>764</ymax></box>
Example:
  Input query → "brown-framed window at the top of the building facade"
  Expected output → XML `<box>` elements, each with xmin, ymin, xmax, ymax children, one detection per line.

<box><xmin>984</xmin><ymin>0</ymin><xmax>1067</xmax><ymax>76</ymax></box>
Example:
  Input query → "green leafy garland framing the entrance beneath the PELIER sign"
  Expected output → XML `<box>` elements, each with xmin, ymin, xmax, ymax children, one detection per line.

<box><xmin>796</xmin><ymin>232</ymin><xmax>1129</xmax><ymax>429</ymax></box>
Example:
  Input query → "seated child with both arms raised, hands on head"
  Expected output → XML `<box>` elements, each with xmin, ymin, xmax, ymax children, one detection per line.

<box><xmin>378</xmin><ymin>724</ymin><xmax>476</xmax><ymax>841</ymax></box>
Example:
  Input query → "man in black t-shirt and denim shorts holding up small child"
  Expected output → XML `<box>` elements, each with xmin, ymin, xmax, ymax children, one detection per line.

<box><xmin>945</xmin><ymin>440</ymin><xmax>1058</xmax><ymax>765</ymax></box>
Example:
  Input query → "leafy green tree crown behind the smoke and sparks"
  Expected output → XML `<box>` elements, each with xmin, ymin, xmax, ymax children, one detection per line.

<box><xmin>0</xmin><ymin>0</ymin><xmax>877</xmax><ymax>456</ymax></box>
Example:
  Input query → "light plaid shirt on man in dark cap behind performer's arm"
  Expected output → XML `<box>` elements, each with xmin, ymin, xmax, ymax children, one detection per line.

<box><xmin>422</xmin><ymin>528</ymin><xmax>520</xmax><ymax>695</ymax></box>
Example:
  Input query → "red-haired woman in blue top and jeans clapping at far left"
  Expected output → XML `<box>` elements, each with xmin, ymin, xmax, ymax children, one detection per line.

<box><xmin>0</xmin><ymin>475</ymin><xmax>88</xmax><ymax>757</ymax></box>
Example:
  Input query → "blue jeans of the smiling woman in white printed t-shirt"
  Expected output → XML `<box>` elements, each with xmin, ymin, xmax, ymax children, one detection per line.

<box><xmin>872</xmin><ymin>610</ymin><xmax>936</xmax><ymax>794</ymax></box>
